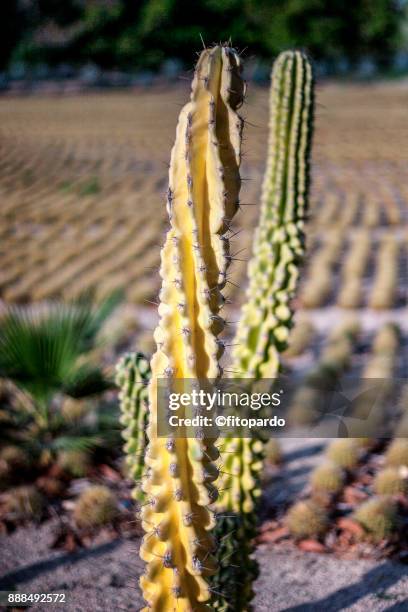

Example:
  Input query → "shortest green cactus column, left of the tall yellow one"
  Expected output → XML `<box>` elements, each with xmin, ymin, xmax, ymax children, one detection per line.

<box><xmin>116</xmin><ymin>353</ymin><xmax>150</xmax><ymax>502</ymax></box>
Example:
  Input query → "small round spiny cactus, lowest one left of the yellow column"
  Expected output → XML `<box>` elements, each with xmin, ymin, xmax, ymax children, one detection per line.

<box><xmin>74</xmin><ymin>485</ymin><xmax>118</xmax><ymax>529</ymax></box>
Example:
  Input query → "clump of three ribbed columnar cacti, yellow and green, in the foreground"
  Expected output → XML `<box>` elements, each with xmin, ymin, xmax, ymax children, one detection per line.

<box><xmin>118</xmin><ymin>46</ymin><xmax>314</xmax><ymax>612</ymax></box>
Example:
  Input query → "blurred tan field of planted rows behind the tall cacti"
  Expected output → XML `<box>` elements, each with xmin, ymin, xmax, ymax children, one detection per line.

<box><xmin>0</xmin><ymin>85</ymin><xmax>408</xmax><ymax>312</ymax></box>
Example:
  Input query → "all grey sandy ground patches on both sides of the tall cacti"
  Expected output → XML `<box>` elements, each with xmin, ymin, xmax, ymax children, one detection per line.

<box><xmin>0</xmin><ymin>439</ymin><xmax>408</xmax><ymax>612</ymax></box>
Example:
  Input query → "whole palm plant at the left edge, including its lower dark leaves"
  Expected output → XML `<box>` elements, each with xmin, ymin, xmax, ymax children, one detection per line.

<box><xmin>0</xmin><ymin>293</ymin><xmax>121</xmax><ymax>456</ymax></box>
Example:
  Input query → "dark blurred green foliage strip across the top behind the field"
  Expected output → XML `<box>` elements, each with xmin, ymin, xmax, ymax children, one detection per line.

<box><xmin>0</xmin><ymin>0</ymin><xmax>406</xmax><ymax>69</ymax></box>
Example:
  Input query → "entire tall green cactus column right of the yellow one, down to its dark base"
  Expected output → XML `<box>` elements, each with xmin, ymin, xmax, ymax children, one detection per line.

<box><xmin>215</xmin><ymin>51</ymin><xmax>314</xmax><ymax>610</ymax></box>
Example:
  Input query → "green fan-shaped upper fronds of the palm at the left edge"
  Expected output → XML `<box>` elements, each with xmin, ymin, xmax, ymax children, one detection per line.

<box><xmin>0</xmin><ymin>294</ymin><xmax>120</xmax><ymax>404</ymax></box>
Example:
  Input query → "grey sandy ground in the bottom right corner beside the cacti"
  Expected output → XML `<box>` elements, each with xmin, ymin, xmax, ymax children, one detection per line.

<box><xmin>255</xmin><ymin>547</ymin><xmax>408</xmax><ymax>612</ymax></box>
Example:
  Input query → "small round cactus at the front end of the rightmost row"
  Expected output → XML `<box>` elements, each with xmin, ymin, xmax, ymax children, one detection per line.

<box><xmin>353</xmin><ymin>497</ymin><xmax>398</xmax><ymax>542</ymax></box>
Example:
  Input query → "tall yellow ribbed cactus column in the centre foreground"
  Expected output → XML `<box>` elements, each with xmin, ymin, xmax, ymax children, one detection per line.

<box><xmin>141</xmin><ymin>46</ymin><xmax>244</xmax><ymax>612</ymax></box>
